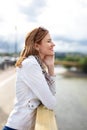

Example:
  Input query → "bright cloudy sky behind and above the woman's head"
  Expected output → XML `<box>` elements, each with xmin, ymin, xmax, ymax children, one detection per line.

<box><xmin>0</xmin><ymin>0</ymin><xmax>87</xmax><ymax>53</ymax></box>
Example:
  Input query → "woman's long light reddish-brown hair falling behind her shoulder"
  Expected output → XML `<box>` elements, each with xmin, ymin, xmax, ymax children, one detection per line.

<box><xmin>15</xmin><ymin>27</ymin><xmax>48</xmax><ymax>67</ymax></box>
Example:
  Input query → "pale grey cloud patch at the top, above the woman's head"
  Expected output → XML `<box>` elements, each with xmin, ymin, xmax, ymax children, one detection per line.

<box><xmin>20</xmin><ymin>0</ymin><xmax>46</xmax><ymax>22</ymax></box>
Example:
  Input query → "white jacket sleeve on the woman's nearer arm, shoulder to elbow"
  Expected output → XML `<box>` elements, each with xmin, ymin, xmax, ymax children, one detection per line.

<box><xmin>22</xmin><ymin>59</ymin><xmax>56</xmax><ymax>109</ymax></box>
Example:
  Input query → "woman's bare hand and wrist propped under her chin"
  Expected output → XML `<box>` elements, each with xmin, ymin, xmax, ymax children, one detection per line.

<box><xmin>43</xmin><ymin>55</ymin><xmax>54</xmax><ymax>76</ymax></box>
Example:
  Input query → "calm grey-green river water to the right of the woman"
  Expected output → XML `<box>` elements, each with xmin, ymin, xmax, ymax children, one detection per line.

<box><xmin>55</xmin><ymin>68</ymin><xmax>87</xmax><ymax>130</ymax></box>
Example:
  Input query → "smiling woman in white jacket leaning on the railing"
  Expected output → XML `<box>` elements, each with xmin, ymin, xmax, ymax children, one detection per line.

<box><xmin>3</xmin><ymin>27</ymin><xmax>56</xmax><ymax>130</ymax></box>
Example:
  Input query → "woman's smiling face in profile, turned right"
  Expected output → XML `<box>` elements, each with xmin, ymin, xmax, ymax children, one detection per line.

<box><xmin>38</xmin><ymin>33</ymin><xmax>55</xmax><ymax>57</ymax></box>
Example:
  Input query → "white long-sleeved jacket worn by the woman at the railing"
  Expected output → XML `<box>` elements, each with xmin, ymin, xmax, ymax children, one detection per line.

<box><xmin>6</xmin><ymin>56</ymin><xmax>56</xmax><ymax>130</ymax></box>
